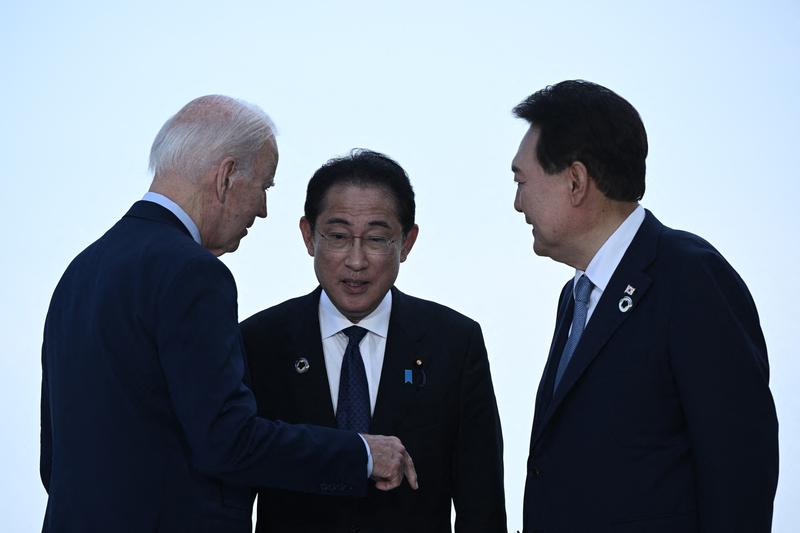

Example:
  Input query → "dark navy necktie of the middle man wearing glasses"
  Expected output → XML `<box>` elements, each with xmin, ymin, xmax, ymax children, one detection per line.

<box><xmin>336</xmin><ymin>326</ymin><xmax>371</xmax><ymax>433</ymax></box>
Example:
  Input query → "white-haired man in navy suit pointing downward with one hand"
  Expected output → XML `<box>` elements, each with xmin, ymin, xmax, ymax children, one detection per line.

<box><xmin>40</xmin><ymin>96</ymin><xmax>416</xmax><ymax>533</ymax></box>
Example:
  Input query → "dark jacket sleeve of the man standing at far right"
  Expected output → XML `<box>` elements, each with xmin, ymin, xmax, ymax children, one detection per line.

<box><xmin>669</xmin><ymin>250</ymin><xmax>778</xmax><ymax>533</ymax></box>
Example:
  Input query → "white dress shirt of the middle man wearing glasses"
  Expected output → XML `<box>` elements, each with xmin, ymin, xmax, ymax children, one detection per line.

<box><xmin>319</xmin><ymin>291</ymin><xmax>392</xmax><ymax>414</ymax></box>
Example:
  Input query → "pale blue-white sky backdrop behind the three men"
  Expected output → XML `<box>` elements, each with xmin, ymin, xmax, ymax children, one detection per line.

<box><xmin>0</xmin><ymin>0</ymin><xmax>800</xmax><ymax>533</ymax></box>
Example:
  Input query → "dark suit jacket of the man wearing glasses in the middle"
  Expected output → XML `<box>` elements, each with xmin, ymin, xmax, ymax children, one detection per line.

<box><xmin>241</xmin><ymin>288</ymin><xmax>506</xmax><ymax>533</ymax></box>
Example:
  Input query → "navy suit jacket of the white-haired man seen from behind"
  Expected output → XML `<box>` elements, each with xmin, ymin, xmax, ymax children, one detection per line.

<box><xmin>41</xmin><ymin>202</ymin><xmax>367</xmax><ymax>533</ymax></box>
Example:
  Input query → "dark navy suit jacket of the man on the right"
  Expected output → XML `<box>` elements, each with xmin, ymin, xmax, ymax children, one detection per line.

<box><xmin>524</xmin><ymin>211</ymin><xmax>778</xmax><ymax>533</ymax></box>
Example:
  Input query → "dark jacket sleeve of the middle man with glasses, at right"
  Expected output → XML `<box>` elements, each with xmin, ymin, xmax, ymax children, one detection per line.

<box><xmin>453</xmin><ymin>324</ymin><xmax>507</xmax><ymax>533</ymax></box>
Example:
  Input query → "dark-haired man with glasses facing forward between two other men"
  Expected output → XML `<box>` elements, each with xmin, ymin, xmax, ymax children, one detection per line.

<box><xmin>241</xmin><ymin>150</ymin><xmax>506</xmax><ymax>533</ymax></box>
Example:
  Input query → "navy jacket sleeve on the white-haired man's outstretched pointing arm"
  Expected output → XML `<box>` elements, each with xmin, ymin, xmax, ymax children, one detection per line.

<box><xmin>156</xmin><ymin>256</ymin><xmax>367</xmax><ymax>495</ymax></box>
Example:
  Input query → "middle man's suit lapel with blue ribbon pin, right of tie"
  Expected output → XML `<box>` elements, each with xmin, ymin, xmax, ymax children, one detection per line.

<box><xmin>370</xmin><ymin>288</ymin><xmax>425</xmax><ymax>435</ymax></box>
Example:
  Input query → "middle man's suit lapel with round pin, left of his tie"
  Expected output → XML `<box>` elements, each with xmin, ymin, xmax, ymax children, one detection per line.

<box><xmin>285</xmin><ymin>287</ymin><xmax>336</xmax><ymax>427</ymax></box>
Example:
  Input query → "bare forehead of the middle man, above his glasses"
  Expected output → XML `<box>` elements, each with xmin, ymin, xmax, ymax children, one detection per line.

<box><xmin>319</xmin><ymin>183</ymin><xmax>400</xmax><ymax>225</ymax></box>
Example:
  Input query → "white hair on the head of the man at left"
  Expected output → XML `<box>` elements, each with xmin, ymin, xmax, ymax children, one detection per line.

<box><xmin>150</xmin><ymin>95</ymin><xmax>275</xmax><ymax>180</ymax></box>
